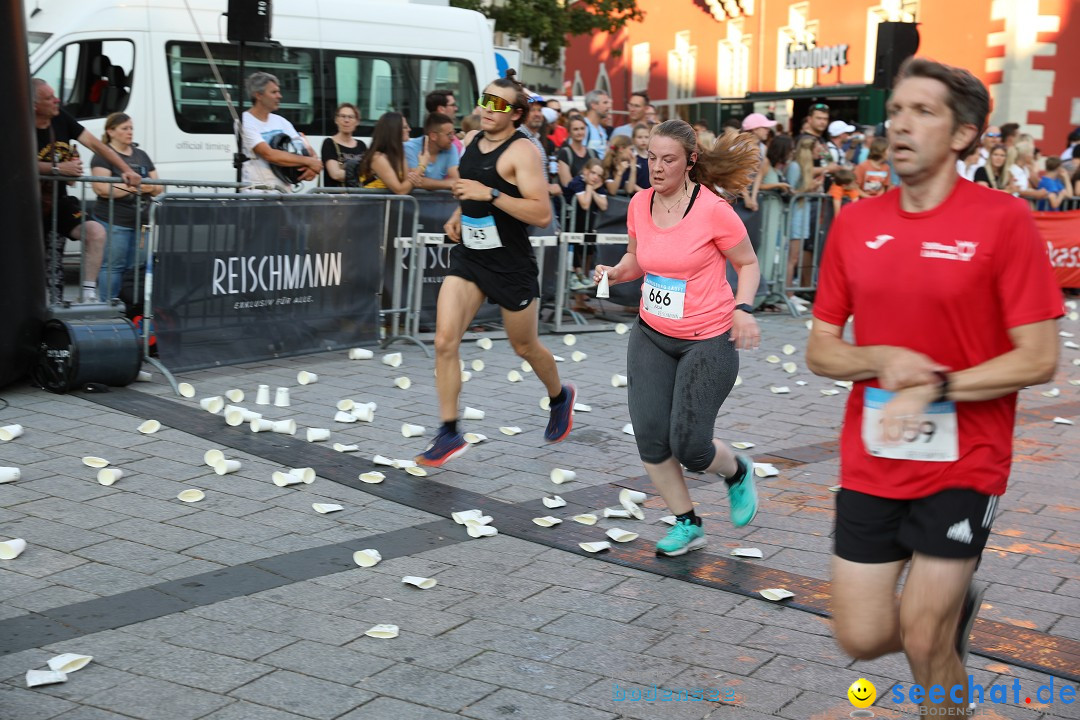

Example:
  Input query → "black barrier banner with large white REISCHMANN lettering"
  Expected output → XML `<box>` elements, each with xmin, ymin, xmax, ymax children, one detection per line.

<box><xmin>152</xmin><ymin>194</ymin><xmax>384</xmax><ymax>371</ymax></box>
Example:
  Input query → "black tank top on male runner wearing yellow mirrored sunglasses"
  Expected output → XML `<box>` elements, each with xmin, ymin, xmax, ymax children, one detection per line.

<box><xmin>456</xmin><ymin>133</ymin><xmax>537</xmax><ymax>272</ymax></box>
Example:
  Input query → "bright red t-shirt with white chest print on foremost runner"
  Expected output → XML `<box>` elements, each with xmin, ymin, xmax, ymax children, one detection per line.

<box><xmin>813</xmin><ymin>179</ymin><xmax>1064</xmax><ymax>499</ymax></box>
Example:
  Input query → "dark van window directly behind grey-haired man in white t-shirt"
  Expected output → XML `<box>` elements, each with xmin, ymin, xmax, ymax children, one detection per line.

<box><xmin>165</xmin><ymin>42</ymin><xmax>315</xmax><ymax>135</ymax></box>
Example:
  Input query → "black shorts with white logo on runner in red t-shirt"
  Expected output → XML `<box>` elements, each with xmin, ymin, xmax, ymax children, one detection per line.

<box><xmin>833</xmin><ymin>489</ymin><xmax>998</xmax><ymax>562</ymax></box>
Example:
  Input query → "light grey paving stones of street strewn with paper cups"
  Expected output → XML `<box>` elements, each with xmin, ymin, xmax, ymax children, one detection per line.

<box><xmin>0</xmin><ymin>316</ymin><xmax>1080</xmax><ymax>720</ymax></box>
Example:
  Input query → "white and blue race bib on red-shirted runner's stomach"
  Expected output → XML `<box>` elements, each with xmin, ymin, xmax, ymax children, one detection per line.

<box><xmin>863</xmin><ymin>388</ymin><xmax>960</xmax><ymax>462</ymax></box>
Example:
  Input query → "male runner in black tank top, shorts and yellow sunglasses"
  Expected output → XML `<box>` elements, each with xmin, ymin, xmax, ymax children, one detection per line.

<box><xmin>416</xmin><ymin>71</ymin><xmax>577</xmax><ymax>466</ymax></box>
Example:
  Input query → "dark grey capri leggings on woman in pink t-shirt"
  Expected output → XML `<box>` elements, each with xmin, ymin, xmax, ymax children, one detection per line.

<box><xmin>626</xmin><ymin>320</ymin><xmax>739</xmax><ymax>473</ymax></box>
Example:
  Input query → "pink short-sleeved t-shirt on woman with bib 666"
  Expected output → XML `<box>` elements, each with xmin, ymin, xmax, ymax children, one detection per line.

<box><xmin>626</xmin><ymin>188</ymin><xmax>746</xmax><ymax>340</ymax></box>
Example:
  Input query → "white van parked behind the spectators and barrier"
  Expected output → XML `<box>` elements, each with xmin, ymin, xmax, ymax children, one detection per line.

<box><xmin>27</xmin><ymin>0</ymin><xmax>497</xmax><ymax>180</ymax></box>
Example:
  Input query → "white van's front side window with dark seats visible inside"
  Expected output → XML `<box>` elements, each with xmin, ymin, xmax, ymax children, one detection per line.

<box><xmin>35</xmin><ymin>39</ymin><xmax>135</xmax><ymax>120</ymax></box>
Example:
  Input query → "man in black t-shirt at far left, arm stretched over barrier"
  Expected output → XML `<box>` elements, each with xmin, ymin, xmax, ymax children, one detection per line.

<box><xmin>33</xmin><ymin>78</ymin><xmax>143</xmax><ymax>302</ymax></box>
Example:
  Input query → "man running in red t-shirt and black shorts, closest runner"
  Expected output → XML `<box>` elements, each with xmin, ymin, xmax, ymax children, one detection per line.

<box><xmin>807</xmin><ymin>58</ymin><xmax>1063</xmax><ymax>712</ymax></box>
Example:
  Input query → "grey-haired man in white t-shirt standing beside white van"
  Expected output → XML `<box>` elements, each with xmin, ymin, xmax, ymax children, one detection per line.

<box><xmin>241</xmin><ymin>72</ymin><xmax>323</xmax><ymax>192</ymax></box>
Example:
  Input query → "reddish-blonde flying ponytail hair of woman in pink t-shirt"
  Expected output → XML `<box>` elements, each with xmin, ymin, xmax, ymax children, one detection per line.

<box><xmin>652</xmin><ymin>120</ymin><xmax>761</xmax><ymax>194</ymax></box>
